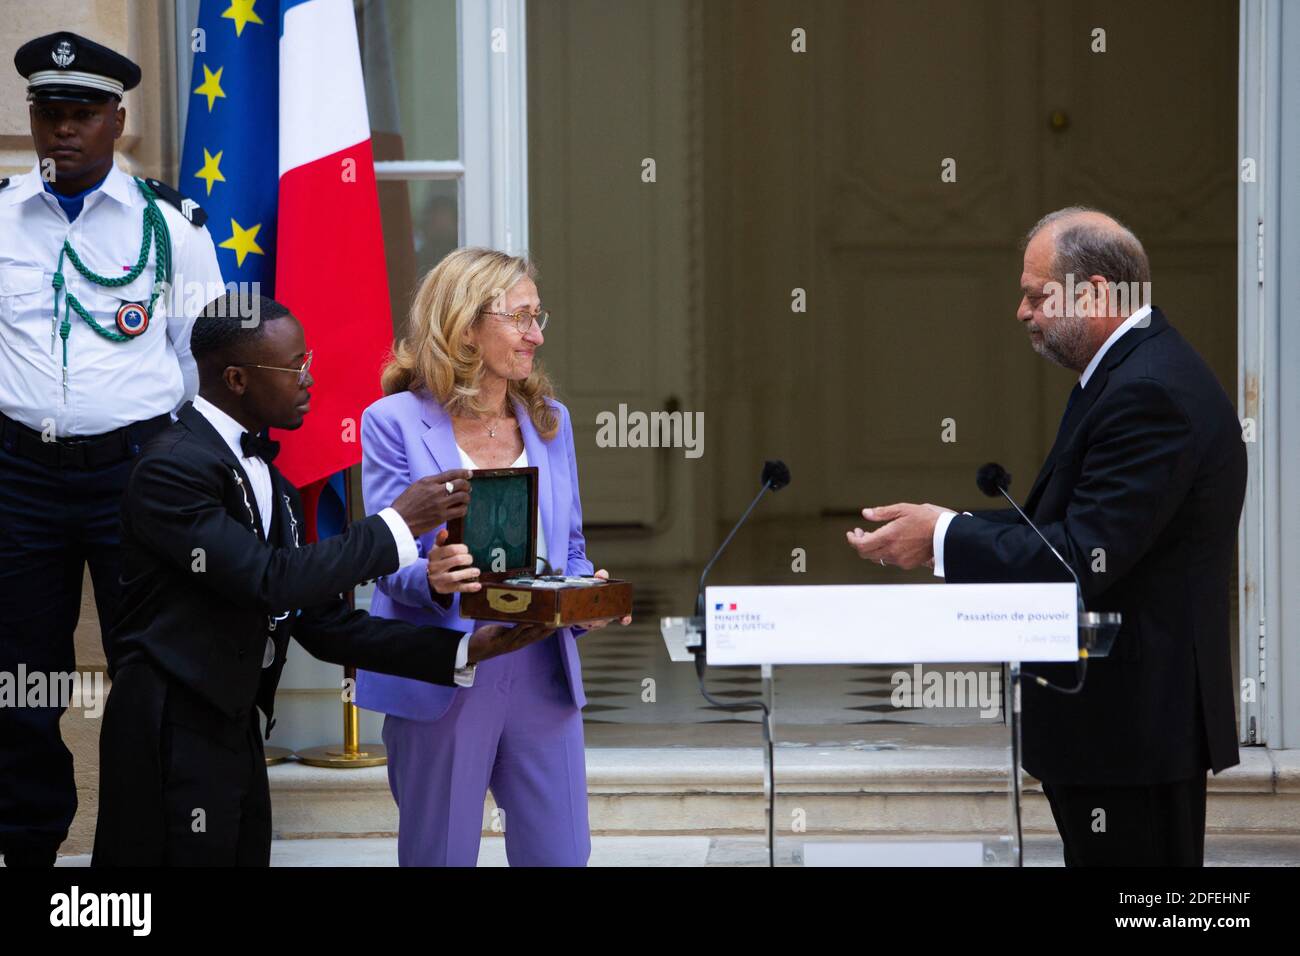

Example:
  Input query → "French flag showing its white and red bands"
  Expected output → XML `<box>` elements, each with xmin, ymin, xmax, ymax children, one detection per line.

<box><xmin>274</xmin><ymin>0</ymin><xmax>393</xmax><ymax>488</ymax></box>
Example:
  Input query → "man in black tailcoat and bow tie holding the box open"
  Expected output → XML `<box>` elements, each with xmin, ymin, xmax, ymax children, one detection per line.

<box><xmin>94</xmin><ymin>295</ymin><xmax>549</xmax><ymax>866</ymax></box>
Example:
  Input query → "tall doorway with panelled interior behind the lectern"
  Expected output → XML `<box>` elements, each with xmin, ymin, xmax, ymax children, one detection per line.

<box><xmin>528</xmin><ymin>0</ymin><xmax>1238</xmax><ymax>745</ymax></box>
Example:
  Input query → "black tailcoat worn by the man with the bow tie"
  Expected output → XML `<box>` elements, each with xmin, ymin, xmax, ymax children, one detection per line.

<box><xmin>109</xmin><ymin>403</ymin><xmax>462</xmax><ymax>736</ymax></box>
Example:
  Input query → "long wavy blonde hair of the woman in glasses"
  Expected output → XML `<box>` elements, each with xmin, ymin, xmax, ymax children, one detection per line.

<box><xmin>380</xmin><ymin>247</ymin><xmax>559</xmax><ymax>440</ymax></box>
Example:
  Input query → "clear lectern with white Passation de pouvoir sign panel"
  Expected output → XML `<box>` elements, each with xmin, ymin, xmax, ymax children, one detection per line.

<box><xmin>662</xmin><ymin>583</ymin><xmax>1118</xmax><ymax>866</ymax></box>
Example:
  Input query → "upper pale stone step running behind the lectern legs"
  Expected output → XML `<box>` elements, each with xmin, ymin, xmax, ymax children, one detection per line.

<box><xmin>269</xmin><ymin>745</ymin><xmax>1300</xmax><ymax>839</ymax></box>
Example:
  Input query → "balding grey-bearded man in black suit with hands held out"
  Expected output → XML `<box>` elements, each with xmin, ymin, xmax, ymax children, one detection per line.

<box><xmin>848</xmin><ymin>207</ymin><xmax>1245</xmax><ymax>866</ymax></box>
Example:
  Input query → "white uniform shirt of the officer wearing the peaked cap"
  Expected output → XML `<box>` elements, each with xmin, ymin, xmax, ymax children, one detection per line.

<box><xmin>0</xmin><ymin>166</ymin><xmax>225</xmax><ymax>438</ymax></box>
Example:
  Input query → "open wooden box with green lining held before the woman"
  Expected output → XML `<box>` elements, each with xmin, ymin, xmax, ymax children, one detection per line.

<box><xmin>447</xmin><ymin>468</ymin><xmax>632</xmax><ymax>627</ymax></box>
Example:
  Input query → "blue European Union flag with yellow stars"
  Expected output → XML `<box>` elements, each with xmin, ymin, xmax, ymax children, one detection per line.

<box><xmin>179</xmin><ymin>0</ymin><xmax>280</xmax><ymax>295</ymax></box>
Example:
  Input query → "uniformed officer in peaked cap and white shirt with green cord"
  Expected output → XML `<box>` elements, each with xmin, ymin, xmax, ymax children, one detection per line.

<box><xmin>0</xmin><ymin>33</ymin><xmax>222</xmax><ymax>866</ymax></box>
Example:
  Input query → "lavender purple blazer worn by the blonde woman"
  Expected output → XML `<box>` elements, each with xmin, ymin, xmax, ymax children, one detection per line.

<box><xmin>356</xmin><ymin>389</ymin><xmax>593</xmax><ymax>721</ymax></box>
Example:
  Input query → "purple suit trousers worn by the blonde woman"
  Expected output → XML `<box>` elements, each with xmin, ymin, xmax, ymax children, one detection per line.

<box><xmin>384</xmin><ymin>635</ymin><xmax>592</xmax><ymax>866</ymax></box>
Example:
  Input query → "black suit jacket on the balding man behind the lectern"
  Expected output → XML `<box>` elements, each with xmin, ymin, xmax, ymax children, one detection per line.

<box><xmin>944</xmin><ymin>310</ymin><xmax>1245</xmax><ymax>784</ymax></box>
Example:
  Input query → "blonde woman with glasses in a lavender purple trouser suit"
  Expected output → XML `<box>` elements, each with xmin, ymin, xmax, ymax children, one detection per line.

<box><xmin>356</xmin><ymin>248</ymin><xmax>631</xmax><ymax>866</ymax></box>
